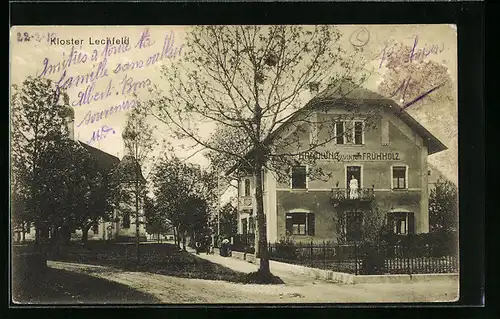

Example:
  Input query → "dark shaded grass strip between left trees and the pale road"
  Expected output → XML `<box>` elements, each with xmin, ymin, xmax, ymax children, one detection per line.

<box><xmin>42</xmin><ymin>242</ymin><xmax>283</xmax><ymax>284</ymax></box>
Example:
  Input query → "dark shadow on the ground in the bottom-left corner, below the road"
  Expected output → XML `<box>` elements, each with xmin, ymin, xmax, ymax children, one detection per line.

<box><xmin>12</xmin><ymin>268</ymin><xmax>159</xmax><ymax>304</ymax></box>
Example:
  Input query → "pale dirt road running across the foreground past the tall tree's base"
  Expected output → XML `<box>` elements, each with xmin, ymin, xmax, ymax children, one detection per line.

<box><xmin>48</xmin><ymin>261</ymin><xmax>458</xmax><ymax>303</ymax></box>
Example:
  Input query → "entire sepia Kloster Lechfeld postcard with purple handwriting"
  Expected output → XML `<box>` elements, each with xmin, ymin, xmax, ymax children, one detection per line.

<box><xmin>10</xmin><ymin>24</ymin><xmax>460</xmax><ymax>305</ymax></box>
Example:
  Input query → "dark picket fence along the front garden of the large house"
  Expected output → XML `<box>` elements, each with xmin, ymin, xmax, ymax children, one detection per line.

<box><xmin>268</xmin><ymin>242</ymin><xmax>458</xmax><ymax>275</ymax></box>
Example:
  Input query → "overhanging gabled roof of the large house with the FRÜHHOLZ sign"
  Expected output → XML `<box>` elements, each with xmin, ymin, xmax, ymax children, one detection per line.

<box><xmin>226</xmin><ymin>82</ymin><xmax>447</xmax><ymax>175</ymax></box>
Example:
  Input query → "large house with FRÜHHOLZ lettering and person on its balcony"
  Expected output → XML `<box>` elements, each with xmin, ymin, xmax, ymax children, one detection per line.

<box><xmin>227</xmin><ymin>89</ymin><xmax>446</xmax><ymax>246</ymax></box>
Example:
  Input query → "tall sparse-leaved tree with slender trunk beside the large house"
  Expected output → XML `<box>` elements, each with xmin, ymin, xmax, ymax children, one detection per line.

<box><xmin>156</xmin><ymin>25</ymin><xmax>376</xmax><ymax>275</ymax></box>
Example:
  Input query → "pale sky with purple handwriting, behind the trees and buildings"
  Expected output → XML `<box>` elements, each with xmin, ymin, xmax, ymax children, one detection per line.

<box><xmin>10</xmin><ymin>25</ymin><xmax>458</xmax><ymax>195</ymax></box>
